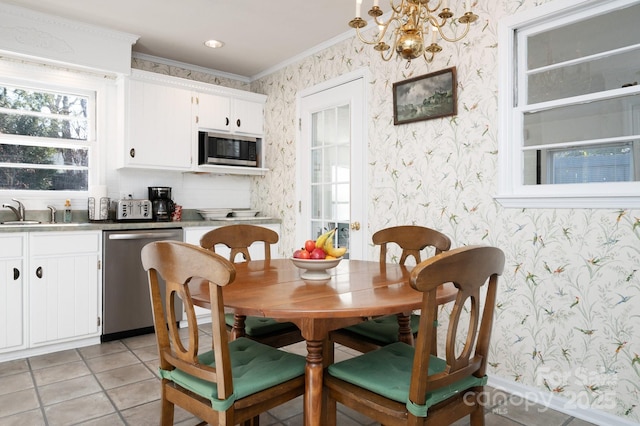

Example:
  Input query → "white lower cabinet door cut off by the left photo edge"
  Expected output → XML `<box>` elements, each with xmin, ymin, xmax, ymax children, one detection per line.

<box><xmin>0</xmin><ymin>233</ymin><xmax>26</xmax><ymax>353</ymax></box>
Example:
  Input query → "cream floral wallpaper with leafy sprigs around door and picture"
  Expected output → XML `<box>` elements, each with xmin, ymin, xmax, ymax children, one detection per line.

<box><xmin>246</xmin><ymin>0</ymin><xmax>640</xmax><ymax>422</ymax></box>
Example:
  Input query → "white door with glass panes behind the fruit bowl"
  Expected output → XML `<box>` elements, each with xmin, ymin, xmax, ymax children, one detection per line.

<box><xmin>297</xmin><ymin>71</ymin><xmax>367</xmax><ymax>259</ymax></box>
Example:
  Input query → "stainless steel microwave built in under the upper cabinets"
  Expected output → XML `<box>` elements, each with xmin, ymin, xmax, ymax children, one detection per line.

<box><xmin>198</xmin><ymin>132</ymin><xmax>259</xmax><ymax>167</ymax></box>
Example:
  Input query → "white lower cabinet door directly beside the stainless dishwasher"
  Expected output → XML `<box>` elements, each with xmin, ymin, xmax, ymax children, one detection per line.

<box><xmin>28</xmin><ymin>231</ymin><xmax>102</xmax><ymax>347</ymax></box>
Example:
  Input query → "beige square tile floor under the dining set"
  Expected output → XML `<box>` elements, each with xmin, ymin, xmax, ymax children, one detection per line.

<box><xmin>0</xmin><ymin>326</ymin><xmax>590</xmax><ymax>426</ymax></box>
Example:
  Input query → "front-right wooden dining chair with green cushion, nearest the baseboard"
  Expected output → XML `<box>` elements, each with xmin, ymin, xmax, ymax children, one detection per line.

<box><xmin>324</xmin><ymin>246</ymin><xmax>505</xmax><ymax>426</ymax></box>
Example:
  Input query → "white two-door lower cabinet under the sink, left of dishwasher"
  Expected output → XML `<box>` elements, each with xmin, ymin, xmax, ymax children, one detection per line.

<box><xmin>0</xmin><ymin>231</ymin><xmax>102</xmax><ymax>361</ymax></box>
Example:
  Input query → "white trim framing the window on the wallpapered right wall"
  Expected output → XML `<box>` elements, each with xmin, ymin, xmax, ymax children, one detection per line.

<box><xmin>494</xmin><ymin>0</ymin><xmax>640</xmax><ymax>208</ymax></box>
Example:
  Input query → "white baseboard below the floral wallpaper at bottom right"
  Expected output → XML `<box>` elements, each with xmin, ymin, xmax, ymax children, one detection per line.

<box><xmin>487</xmin><ymin>376</ymin><xmax>640</xmax><ymax>426</ymax></box>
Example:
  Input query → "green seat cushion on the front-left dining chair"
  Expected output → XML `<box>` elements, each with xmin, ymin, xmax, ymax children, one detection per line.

<box><xmin>160</xmin><ymin>337</ymin><xmax>306</xmax><ymax>411</ymax></box>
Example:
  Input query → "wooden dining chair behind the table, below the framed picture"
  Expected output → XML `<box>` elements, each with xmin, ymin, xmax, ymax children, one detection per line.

<box><xmin>331</xmin><ymin>225</ymin><xmax>451</xmax><ymax>352</ymax></box>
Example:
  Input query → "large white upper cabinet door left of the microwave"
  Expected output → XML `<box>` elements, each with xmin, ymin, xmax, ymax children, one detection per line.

<box><xmin>120</xmin><ymin>73</ymin><xmax>195</xmax><ymax>170</ymax></box>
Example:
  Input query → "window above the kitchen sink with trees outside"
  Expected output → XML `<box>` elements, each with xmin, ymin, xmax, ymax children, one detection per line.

<box><xmin>0</xmin><ymin>82</ymin><xmax>94</xmax><ymax>191</ymax></box>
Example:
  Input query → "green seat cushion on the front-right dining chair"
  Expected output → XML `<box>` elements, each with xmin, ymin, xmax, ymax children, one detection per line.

<box><xmin>328</xmin><ymin>342</ymin><xmax>486</xmax><ymax>417</ymax></box>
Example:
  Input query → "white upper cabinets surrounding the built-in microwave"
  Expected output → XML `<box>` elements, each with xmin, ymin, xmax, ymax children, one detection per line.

<box><xmin>118</xmin><ymin>70</ymin><xmax>267</xmax><ymax>175</ymax></box>
